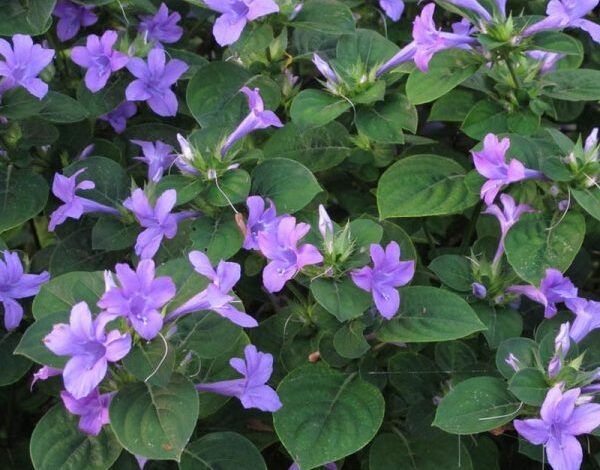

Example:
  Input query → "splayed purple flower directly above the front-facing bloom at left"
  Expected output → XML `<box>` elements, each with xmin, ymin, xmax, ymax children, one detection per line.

<box><xmin>123</xmin><ymin>188</ymin><xmax>196</xmax><ymax>259</ymax></box>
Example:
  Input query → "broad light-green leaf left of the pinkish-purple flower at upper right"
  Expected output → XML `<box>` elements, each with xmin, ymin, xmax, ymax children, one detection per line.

<box><xmin>377</xmin><ymin>155</ymin><xmax>479</xmax><ymax>219</ymax></box>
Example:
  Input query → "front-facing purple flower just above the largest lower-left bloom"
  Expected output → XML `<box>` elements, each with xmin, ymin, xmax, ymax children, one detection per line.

<box><xmin>98</xmin><ymin>259</ymin><xmax>176</xmax><ymax>341</ymax></box>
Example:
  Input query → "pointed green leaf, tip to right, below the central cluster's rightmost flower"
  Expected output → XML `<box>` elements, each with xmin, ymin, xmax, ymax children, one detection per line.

<box><xmin>377</xmin><ymin>286</ymin><xmax>485</xmax><ymax>343</ymax></box>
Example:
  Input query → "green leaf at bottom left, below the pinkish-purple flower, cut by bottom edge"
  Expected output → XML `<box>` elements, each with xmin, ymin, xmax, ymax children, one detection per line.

<box><xmin>30</xmin><ymin>403</ymin><xmax>122</xmax><ymax>470</ymax></box>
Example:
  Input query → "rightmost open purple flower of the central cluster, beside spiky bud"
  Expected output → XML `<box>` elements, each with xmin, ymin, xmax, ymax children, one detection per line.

<box><xmin>350</xmin><ymin>242</ymin><xmax>415</xmax><ymax>320</ymax></box>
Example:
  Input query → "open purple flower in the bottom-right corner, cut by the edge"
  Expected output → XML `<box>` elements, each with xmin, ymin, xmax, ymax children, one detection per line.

<box><xmin>513</xmin><ymin>385</ymin><xmax>600</xmax><ymax>470</ymax></box>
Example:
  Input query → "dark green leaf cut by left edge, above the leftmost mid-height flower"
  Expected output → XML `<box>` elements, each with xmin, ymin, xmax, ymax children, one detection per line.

<box><xmin>0</xmin><ymin>166</ymin><xmax>48</xmax><ymax>232</ymax></box>
